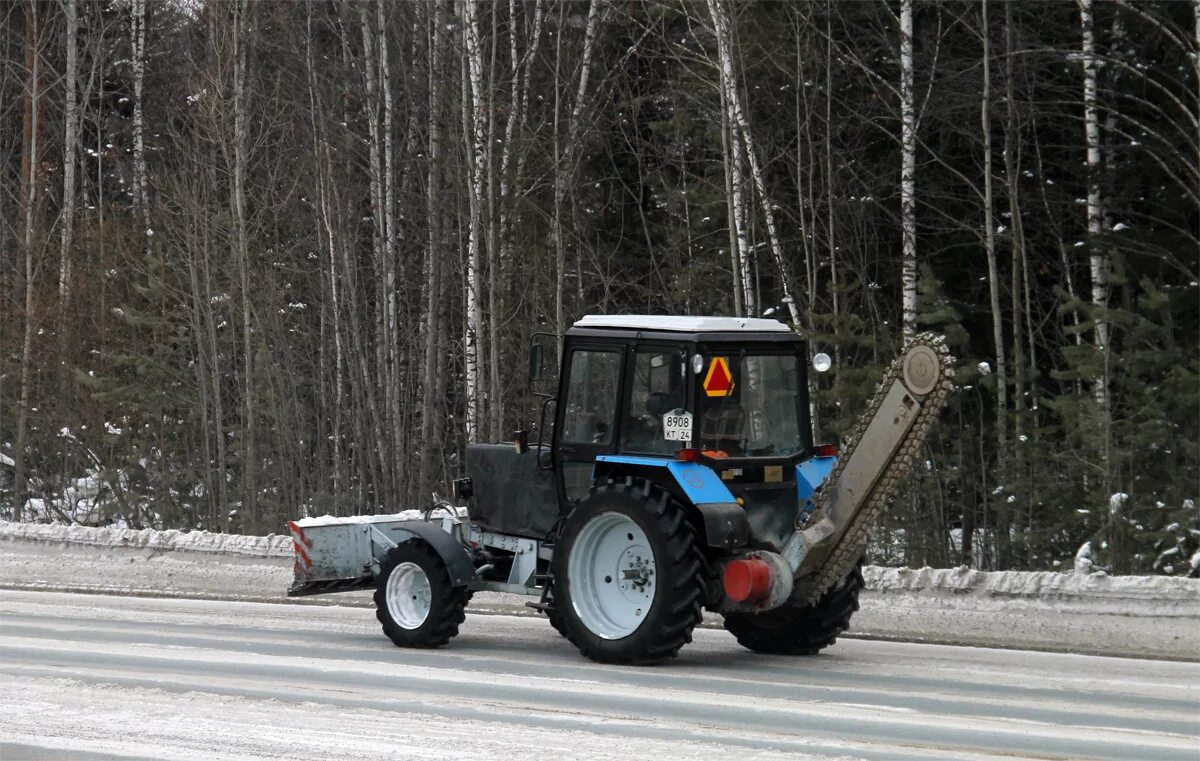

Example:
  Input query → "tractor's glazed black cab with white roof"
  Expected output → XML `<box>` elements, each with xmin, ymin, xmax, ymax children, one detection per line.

<box><xmin>552</xmin><ymin>316</ymin><xmax>812</xmax><ymax>499</ymax></box>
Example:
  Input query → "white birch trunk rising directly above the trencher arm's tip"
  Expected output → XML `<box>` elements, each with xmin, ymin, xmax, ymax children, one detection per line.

<box><xmin>900</xmin><ymin>0</ymin><xmax>917</xmax><ymax>337</ymax></box>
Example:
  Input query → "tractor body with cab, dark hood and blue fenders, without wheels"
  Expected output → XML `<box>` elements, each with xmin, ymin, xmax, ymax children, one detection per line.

<box><xmin>456</xmin><ymin>316</ymin><xmax>833</xmax><ymax>551</ymax></box>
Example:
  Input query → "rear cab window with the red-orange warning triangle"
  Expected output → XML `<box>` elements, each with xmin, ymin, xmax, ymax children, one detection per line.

<box><xmin>695</xmin><ymin>352</ymin><xmax>811</xmax><ymax>457</ymax></box>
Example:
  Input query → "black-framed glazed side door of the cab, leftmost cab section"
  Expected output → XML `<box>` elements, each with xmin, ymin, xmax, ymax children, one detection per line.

<box><xmin>553</xmin><ymin>343</ymin><xmax>625</xmax><ymax>508</ymax></box>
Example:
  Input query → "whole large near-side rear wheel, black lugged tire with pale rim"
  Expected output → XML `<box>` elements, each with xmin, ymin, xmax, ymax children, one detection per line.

<box><xmin>552</xmin><ymin>478</ymin><xmax>704</xmax><ymax>664</ymax></box>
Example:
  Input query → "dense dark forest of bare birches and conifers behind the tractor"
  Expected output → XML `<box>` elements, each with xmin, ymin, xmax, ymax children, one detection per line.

<box><xmin>0</xmin><ymin>0</ymin><xmax>1200</xmax><ymax>574</ymax></box>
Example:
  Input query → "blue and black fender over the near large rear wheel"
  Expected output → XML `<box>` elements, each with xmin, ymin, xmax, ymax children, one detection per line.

<box><xmin>592</xmin><ymin>455</ymin><xmax>750</xmax><ymax>550</ymax></box>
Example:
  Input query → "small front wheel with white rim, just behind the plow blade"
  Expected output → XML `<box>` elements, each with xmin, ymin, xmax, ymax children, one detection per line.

<box><xmin>374</xmin><ymin>539</ymin><xmax>470</xmax><ymax>647</ymax></box>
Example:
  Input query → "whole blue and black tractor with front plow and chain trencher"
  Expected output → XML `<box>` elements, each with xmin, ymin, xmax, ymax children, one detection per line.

<box><xmin>290</xmin><ymin>316</ymin><xmax>950</xmax><ymax>663</ymax></box>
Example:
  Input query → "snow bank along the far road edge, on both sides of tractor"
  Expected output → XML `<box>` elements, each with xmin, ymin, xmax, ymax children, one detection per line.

<box><xmin>0</xmin><ymin>522</ymin><xmax>1200</xmax><ymax>660</ymax></box>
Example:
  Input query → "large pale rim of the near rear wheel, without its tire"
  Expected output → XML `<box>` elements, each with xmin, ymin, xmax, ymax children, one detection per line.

<box><xmin>566</xmin><ymin>513</ymin><xmax>656</xmax><ymax>640</ymax></box>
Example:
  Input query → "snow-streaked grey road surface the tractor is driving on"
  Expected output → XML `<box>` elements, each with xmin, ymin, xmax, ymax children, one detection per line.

<box><xmin>0</xmin><ymin>591</ymin><xmax>1200</xmax><ymax>761</ymax></box>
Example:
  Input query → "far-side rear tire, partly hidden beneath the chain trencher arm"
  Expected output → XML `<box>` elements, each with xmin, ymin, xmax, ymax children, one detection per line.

<box><xmin>725</xmin><ymin>559</ymin><xmax>864</xmax><ymax>655</ymax></box>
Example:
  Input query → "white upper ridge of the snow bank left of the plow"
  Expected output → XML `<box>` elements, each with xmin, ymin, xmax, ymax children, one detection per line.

<box><xmin>0</xmin><ymin>521</ymin><xmax>292</xmax><ymax>557</ymax></box>
